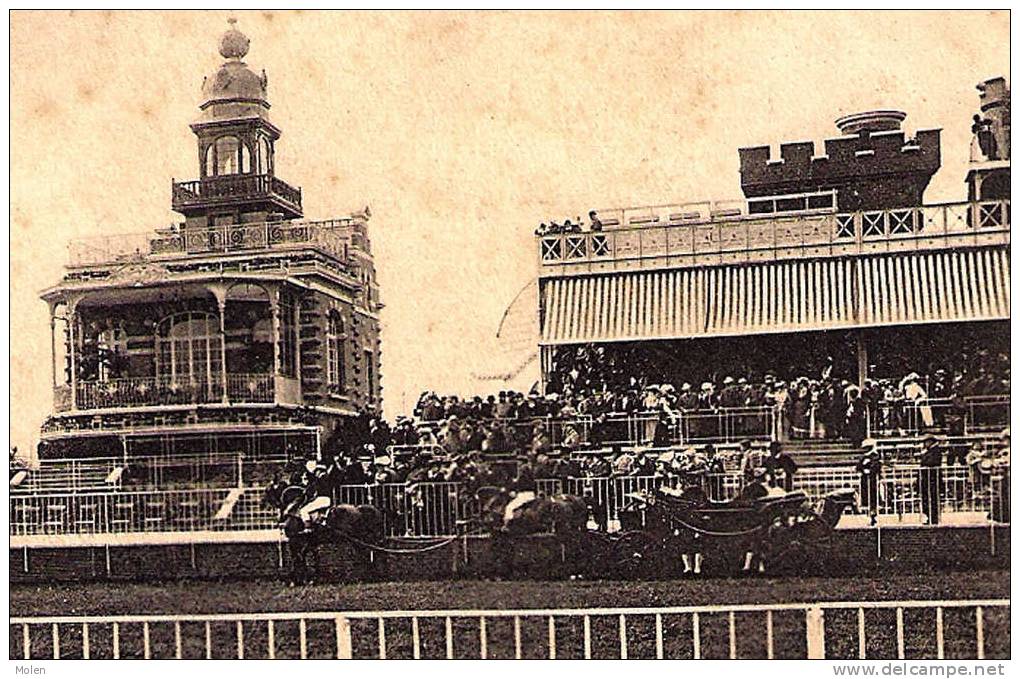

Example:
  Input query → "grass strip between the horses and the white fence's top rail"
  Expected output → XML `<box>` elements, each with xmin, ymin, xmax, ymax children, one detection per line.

<box><xmin>10</xmin><ymin>570</ymin><xmax>1010</xmax><ymax>616</ymax></box>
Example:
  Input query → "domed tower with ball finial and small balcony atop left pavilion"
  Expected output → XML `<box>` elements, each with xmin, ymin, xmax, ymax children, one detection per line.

<box><xmin>173</xmin><ymin>18</ymin><xmax>302</xmax><ymax>221</ymax></box>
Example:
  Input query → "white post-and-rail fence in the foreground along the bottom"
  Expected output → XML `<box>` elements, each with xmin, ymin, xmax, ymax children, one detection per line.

<box><xmin>9</xmin><ymin>599</ymin><xmax>1010</xmax><ymax>660</ymax></box>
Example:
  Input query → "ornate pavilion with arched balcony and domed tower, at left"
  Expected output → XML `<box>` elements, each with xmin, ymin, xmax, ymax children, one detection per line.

<box><xmin>41</xmin><ymin>21</ymin><xmax>381</xmax><ymax>457</ymax></box>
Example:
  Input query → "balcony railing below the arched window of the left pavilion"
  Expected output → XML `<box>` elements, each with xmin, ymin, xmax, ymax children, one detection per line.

<box><xmin>63</xmin><ymin>373</ymin><xmax>286</xmax><ymax>412</ymax></box>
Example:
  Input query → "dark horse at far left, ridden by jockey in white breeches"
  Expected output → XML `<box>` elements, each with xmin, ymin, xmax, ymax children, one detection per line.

<box><xmin>262</xmin><ymin>483</ymin><xmax>386</xmax><ymax>583</ymax></box>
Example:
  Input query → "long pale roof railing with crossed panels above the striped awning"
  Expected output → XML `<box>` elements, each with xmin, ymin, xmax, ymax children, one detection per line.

<box><xmin>538</xmin><ymin>196</ymin><xmax>1010</xmax><ymax>270</ymax></box>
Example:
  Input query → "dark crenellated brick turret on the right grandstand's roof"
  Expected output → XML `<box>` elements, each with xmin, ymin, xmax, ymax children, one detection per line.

<box><xmin>740</xmin><ymin>111</ymin><xmax>941</xmax><ymax>211</ymax></box>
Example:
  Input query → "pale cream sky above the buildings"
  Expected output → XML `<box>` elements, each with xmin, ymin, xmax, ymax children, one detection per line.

<box><xmin>10</xmin><ymin>11</ymin><xmax>1010</xmax><ymax>450</ymax></box>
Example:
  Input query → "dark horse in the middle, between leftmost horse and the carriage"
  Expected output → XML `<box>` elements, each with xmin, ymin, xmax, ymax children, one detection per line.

<box><xmin>475</xmin><ymin>487</ymin><xmax>589</xmax><ymax>577</ymax></box>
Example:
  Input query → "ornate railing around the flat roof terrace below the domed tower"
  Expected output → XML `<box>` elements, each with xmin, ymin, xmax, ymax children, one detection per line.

<box><xmin>69</xmin><ymin>219</ymin><xmax>354</xmax><ymax>267</ymax></box>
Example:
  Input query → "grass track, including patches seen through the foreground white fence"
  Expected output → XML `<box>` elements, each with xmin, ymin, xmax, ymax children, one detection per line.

<box><xmin>10</xmin><ymin>571</ymin><xmax>1010</xmax><ymax>659</ymax></box>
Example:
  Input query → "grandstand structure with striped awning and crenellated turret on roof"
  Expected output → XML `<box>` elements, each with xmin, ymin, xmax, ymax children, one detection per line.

<box><xmin>538</xmin><ymin>79</ymin><xmax>1010</xmax><ymax>389</ymax></box>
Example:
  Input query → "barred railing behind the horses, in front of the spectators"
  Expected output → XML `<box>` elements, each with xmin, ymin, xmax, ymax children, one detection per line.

<box><xmin>10</xmin><ymin>465</ymin><xmax>1010</xmax><ymax>537</ymax></box>
